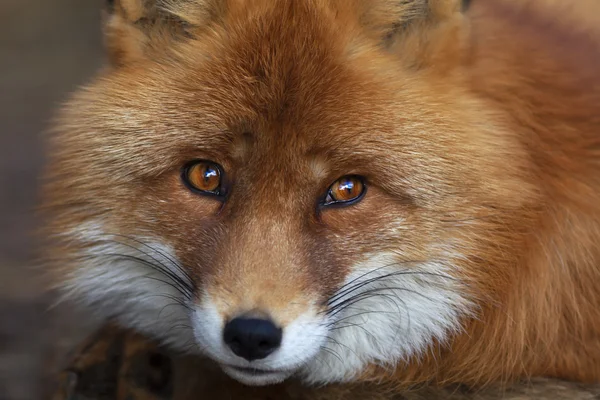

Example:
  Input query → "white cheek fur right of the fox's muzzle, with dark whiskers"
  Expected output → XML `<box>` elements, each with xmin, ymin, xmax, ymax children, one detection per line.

<box><xmin>302</xmin><ymin>254</ymin><xmax>471</xmax><ymax>383</ymax></box>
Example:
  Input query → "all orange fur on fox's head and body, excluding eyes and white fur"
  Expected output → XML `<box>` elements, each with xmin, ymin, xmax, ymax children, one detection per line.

<box><xmin>45</xmin><ymin>0</ymin><xmax>600</xmax><ymax>387</ymax></box>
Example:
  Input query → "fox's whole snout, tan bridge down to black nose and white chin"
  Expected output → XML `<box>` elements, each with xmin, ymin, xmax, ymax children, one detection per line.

<box><xmin>192</xmin><ymin>213</ymin><xmax>327</xmax><ymax>384</ymax></box>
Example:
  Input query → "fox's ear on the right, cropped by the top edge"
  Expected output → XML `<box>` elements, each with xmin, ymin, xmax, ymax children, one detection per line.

<box><xmin>358</xmin><ymin>0</ymin><xmax>471</xmax><ymax>69</ymax></box>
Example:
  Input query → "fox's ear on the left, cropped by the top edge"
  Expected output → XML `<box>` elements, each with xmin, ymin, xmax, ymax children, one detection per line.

<box><xmin>104</xmin><ymin>0</ymin><xmax>225</xmax><ymax>66</ymax></box>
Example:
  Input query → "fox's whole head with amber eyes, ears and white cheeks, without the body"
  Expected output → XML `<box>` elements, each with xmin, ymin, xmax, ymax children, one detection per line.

<box><xmin>44</xmin><ymin>0</ymin><xmax>600</xmax><ymax>385</ymax></box>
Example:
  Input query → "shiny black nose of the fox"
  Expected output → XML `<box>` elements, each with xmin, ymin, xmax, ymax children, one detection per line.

<box><xmin>223</xmin><ymin>318</ymin><xmax>282</xmax><ymax>361</ymax></box>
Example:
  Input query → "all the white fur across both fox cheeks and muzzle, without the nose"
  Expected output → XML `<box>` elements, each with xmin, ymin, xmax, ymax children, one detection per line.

<box><xmin>63</xmin><ymin>224</ymin><xmax>472</xmax><ymax>384</ymax></box>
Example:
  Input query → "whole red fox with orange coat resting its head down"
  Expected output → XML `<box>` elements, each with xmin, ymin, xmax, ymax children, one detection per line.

<box><xmin>42</xmin><ymin>0</ymin><xmax>600</xmax><ymax>387</ymax></box>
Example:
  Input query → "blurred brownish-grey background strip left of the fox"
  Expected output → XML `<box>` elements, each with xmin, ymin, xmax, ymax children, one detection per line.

<box><xmin>0</xmin><ymin>0</ymin><xmax>104</xmax><ymax>400</ymax></box>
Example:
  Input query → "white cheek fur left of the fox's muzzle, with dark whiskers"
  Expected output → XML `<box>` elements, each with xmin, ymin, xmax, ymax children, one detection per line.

<box><xmin>62</xmin><ymin>223</ymin><xmax>197</xmax><ymax>352</ymax></box>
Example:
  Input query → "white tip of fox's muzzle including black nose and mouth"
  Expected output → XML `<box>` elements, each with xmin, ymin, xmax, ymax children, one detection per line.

<box><xmin>192</xmin><ymin>288</ymin><xmax>327</xmax><ymax>385</ymax></box>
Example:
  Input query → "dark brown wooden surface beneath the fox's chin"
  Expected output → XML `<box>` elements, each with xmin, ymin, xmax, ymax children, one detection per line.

<box><xmin>53</xmin><ymin>327</ymin><xmax>600</xmax><ymax>400</ymax></box>
